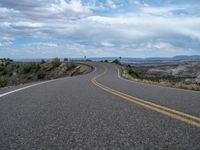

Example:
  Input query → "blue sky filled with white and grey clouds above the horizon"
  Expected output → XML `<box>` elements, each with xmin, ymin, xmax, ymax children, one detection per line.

<box><xmin>0</xmin><ymin>0</ymin><xmax>200</xmax><ymax>59</ymax></box>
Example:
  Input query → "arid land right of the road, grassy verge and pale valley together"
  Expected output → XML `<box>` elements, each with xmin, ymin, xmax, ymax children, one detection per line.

<box><xmin>124</xmin><ymin>60</ymin><xmax>200</xmax><ymax>90</ymax></box>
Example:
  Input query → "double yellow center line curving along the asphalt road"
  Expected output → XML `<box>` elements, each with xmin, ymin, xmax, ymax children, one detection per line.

<box><xmin>91</xmin><ymin>67</ymin><xmax>200</xmax><ymax>127</ymax></box>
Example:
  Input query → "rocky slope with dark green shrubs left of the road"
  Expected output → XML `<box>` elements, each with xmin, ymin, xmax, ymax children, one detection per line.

<box><xmin>0</xmin><ymin>58</ymin><xmax>91</xmax><ymax>87</ymax></box>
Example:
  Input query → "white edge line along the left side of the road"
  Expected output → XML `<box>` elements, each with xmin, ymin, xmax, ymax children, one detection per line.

<box><xmin>0</xmin><ymin>63</ymin><xmax>97</xmax><ymax>97</ymax></box>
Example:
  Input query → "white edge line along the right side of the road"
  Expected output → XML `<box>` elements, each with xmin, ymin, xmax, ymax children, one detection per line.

<box><xmin>116</xmin><ymin>66</ymin><xmax>199</xmax><ymax>93</ymax></box>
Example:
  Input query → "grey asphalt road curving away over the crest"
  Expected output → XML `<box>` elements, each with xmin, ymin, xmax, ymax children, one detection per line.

<box><xmin>0</xmin><ymin>63</ymin><xmax>200</xmax><ymax>150</ymax></box>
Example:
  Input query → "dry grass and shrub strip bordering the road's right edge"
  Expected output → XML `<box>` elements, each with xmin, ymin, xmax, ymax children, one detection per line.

<box><xmin>122</xmin><ymin>65</ymin><xmax>200</xmax><ymax>91</ymax></box>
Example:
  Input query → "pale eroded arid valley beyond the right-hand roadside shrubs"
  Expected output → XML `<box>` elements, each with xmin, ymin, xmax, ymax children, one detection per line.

<box><xmin>133</xmin><ymin>61</ymin><xmax>200</xmax><ymax>83</ymax></box>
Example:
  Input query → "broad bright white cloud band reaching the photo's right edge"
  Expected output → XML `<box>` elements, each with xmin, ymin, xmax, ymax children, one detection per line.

<box><xmin>87</xmin><ymin>14</ymin><xmax>200</xmax><ymax>40</ymax></box>
